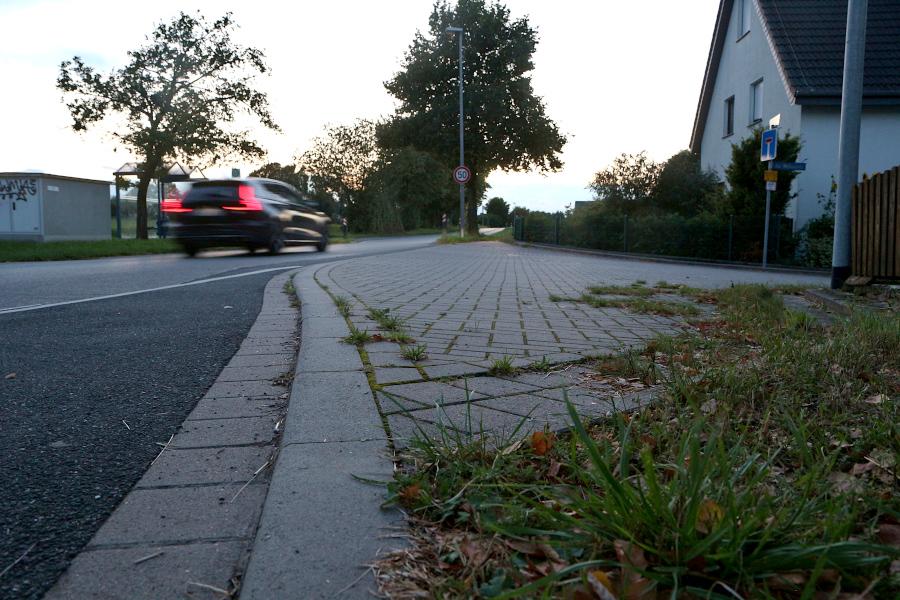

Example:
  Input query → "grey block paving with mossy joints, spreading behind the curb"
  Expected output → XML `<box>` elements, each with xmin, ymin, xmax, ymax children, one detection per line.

<box><xmin>316</xmin><ymin>243</ymin><xmax>825</xmax><ymax>441</ymax></box>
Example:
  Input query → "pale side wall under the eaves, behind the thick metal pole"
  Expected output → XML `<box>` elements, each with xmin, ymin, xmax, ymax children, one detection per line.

<box><xmin>794</xmin><ymin>106</ymin><xmax>900</xmax><ymax>225</ymax></box>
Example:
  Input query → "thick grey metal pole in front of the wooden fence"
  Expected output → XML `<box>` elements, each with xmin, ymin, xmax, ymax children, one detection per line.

<box><xmin>831</xmin><ymin>0</ymin><xmax>869</xmax><ymax>289</ymax></box>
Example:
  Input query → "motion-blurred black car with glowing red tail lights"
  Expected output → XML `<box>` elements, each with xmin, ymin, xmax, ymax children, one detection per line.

<box><xmin>162</xmin><ymin>178</ymin><xmax>331</xmax><ymax>256</ymax></box>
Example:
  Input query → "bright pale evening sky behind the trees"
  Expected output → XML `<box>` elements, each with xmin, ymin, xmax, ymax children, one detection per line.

<box><xmin>0</xmin><ymin>0</ymin><xmax>718</xmax><ymax>210</ymax></box>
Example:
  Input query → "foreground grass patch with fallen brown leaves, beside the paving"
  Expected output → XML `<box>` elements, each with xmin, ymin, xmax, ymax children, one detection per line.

<box><xmin>376</xmin><ymin>286</ymin><xmax>900</xmax><ymax>600</ymax></box>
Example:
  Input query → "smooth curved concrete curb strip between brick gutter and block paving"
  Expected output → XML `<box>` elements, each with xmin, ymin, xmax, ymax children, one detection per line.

<box><xmin>241</xmin><ymin>268</ymin><xmax>403</xmax><ymax>600</ymax></box>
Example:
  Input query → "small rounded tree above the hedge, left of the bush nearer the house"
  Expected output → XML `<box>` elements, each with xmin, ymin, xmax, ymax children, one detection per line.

<box><xmin>589</xmin><ymin>152</ymin><xmax>662</xmax><ymax>216</ymax></box>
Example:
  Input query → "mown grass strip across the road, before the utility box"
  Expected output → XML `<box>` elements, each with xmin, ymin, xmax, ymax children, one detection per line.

<box><xmin>0</xmin><ymin>239</ymin><xmax>181</xmax><ymax>262</ymax></box>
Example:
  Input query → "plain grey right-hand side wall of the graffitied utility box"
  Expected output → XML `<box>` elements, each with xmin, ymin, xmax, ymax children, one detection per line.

<box><xmin>41</xmin><ymin>176</ymin><xmax>111</xmax><ymax>241</ymax></box>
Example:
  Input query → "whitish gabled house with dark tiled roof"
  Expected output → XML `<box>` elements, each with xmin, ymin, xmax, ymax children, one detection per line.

<box><xmin>690</xmin><ymin>0</ymin><xmax>900</xmax><ymax>228</ymax></box>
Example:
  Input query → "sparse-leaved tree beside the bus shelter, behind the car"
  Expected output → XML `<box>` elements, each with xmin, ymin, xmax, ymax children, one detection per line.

<box><xmin>57</xmin><ymin>12</ymin><xmax>278</xmax><ymax>239</ymax></box>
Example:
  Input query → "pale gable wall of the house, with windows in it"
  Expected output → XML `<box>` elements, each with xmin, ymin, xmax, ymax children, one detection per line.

<box><xmin>700</xmin><ymin>0</ymin><xmax>801</xmax><ymax>184</ymax></box>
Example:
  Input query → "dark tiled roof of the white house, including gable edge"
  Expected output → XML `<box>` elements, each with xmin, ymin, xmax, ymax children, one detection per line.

<box><xmin>691</xmin><ymin>0</ymin><xmax>900</xmax><ymax>152</ymax></box>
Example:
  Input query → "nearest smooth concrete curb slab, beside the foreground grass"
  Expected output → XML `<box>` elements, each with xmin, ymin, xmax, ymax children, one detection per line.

<box><xmin>241</xmin><ymin>441</ymin><xmax>402</xmax><ymax>600</ymax></box>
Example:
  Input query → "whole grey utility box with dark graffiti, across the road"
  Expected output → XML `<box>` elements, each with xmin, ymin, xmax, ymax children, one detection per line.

<box><xmin>0</xmin><ymin>173</ymin><xmax>112</xmax><ymax>242</ymax></box>
